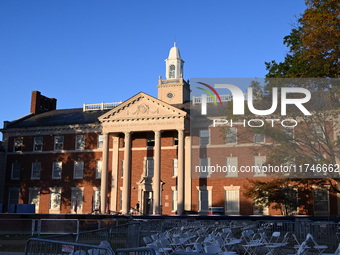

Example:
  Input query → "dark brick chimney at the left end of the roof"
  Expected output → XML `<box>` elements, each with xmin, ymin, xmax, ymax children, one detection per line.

<box><xmin>31</xmin><ymin>91</ymin><xmax>57</xmax><ymax>114</ymax></box>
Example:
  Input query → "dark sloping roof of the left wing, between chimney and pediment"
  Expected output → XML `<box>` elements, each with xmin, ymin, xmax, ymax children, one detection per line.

<box><xmin>6</xmin><ymin>108</ymin><xmax>108</xmax><ymax>128</ymax></box>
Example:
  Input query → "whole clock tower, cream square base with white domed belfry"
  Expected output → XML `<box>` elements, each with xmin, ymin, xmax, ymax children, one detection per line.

<box><xmin>158</xmin><ymin>43</ymin><xmax>190</xmax><ymax>104</ymax></box>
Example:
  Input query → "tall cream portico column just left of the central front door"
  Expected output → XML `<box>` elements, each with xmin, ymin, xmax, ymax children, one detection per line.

<box><xmin>122</xmin><ymin>132</ymin><xmax>131</xmax><ymax>214</ymax></box>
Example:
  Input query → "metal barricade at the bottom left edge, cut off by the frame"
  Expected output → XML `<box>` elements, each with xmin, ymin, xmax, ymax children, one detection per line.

<box><xmin>25</xmin><ymin>238</ymin><xmax>114</xmax><ymax>255</ymax></box>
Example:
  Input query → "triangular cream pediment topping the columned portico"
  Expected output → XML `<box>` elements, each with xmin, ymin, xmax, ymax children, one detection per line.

<box><xmin>99</xmin><ymin>92</ymin><xmax>187</xmax><ymax>122</ymax></box>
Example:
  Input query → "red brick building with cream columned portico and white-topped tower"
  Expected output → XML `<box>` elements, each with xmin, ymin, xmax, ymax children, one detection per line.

<box><xmin>2</xmin><ymin>45</ymin><xmax>338</xmax><ymax>215</ymax></box>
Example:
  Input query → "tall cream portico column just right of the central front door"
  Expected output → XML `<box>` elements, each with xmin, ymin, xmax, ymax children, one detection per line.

<box><xmin>152</xmin><ymin>130</ymin><xmax>161</xmax><ymax>214</ymax></box>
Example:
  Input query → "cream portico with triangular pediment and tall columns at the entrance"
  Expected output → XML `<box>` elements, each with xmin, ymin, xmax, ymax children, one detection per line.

<box><xmin>99</xmin><ymin>92</ymin><xmax>189</xmax><ymax>214</ymax></box>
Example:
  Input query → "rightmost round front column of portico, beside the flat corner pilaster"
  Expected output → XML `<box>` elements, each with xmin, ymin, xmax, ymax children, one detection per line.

<box><xmin>177</xmin><ymin>130</ymin><xmax>184</xmax><ymax>215</ymax></box>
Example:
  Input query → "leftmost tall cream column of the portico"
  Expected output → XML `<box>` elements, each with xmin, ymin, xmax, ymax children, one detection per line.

<box><xmin>100</xmin><ymin>133</ymin><xmax>109</xmax><ymax>213</ymax></box>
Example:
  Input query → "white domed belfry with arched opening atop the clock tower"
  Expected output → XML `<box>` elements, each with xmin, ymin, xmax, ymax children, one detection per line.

<box><xmin>165</xmin><ymin>42</ymin><xmax>184</xmax><ymax>80</ymax></box>
